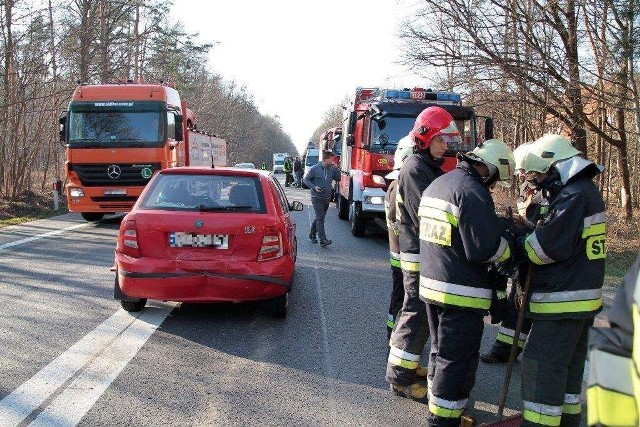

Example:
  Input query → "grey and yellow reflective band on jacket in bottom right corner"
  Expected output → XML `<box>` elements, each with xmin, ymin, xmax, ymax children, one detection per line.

<box><xmin>587</xmin><ymin>349</ymin><xmax>638</xmax><ymax>427</ymax></box>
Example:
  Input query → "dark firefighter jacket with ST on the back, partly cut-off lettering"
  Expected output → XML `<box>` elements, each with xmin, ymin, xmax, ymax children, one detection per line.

<box><xmin>524</xmin><ymin>158</ymin><xmax>606</xmax><ymax>319</ymax></box>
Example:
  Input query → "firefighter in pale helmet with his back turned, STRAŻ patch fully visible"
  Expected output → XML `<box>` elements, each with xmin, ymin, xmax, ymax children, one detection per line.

<box><xmin>419</xmin><ymin>139</ymin><xmax>515</xmax><ymax>426</ymax></box>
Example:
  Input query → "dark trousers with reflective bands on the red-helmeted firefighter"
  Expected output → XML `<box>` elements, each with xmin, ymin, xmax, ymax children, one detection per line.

<box><xmin>386</xmin><ymin>270</ymin><xmax>429</xmax><ymax>386</ymax></box>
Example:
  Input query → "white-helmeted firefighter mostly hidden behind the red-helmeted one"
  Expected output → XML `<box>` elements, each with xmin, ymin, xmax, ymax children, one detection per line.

<box><xmin>384</xmin><ymin>135</ymin><xmax>415</xmax><ymax>339</ymax></box>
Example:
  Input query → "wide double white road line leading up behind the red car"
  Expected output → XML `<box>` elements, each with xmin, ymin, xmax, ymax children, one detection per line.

<box><xmin>0</xmin><ymin>304</ymin><xmax>175</xmax><ymax>426</ymax></box>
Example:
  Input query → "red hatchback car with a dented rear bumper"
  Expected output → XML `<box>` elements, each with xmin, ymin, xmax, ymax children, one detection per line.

<box><xmin>114</xmin><ymin>167</ymin><xmax>303</xmax><ymax>317</ymax></box>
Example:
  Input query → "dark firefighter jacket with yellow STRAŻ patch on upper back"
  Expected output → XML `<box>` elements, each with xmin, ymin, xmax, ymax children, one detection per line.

<box><xmin>419</xmin><ymin>161</ymin><xmax>511</xmax><ymax>314</ymax></box>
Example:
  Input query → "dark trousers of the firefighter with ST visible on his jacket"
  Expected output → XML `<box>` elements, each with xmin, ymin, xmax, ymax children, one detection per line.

<box><xmin>522</xmin><ymin>319</ymin><xmax>593</xmax><ymax>426</ymax></box>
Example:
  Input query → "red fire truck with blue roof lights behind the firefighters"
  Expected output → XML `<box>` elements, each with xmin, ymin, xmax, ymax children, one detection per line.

<box><xmin>336</xmin><ymin>88</ymin><xmax>493</xmax><ymax>237</ymax></box>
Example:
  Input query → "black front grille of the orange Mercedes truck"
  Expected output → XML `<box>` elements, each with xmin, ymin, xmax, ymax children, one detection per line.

<box><xmin>69</xmin><ymin>163</ymin><xmax>160</xmax><ymax>187</ymax></box>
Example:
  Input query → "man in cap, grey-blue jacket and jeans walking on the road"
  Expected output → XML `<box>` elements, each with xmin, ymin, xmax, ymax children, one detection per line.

<box><xmin>304</xmin><ymin>151</ymin><xmax>340</xmax><ymax>247</ymax></box>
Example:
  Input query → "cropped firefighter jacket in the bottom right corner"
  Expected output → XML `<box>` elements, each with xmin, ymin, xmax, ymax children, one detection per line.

<box><xmin>587</xmin><ymin>252</ymin><xmax>640</xmax><ymax>426</ymax></box>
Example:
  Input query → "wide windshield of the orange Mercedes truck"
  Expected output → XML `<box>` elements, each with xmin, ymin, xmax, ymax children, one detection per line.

<box><xmin>67</xmin><ymin>102</ymin><xmax>166</xmax><ymax>148</ymax></box>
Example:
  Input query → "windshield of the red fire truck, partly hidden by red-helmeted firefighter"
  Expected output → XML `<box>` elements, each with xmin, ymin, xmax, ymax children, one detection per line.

<box><xmin>369</xmin><ymin>116</ymin><xmax>476</xmax><ymax>154</ymax></box>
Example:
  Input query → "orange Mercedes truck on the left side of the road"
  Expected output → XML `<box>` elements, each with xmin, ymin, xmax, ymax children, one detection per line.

<box><xmin>60</xmin><ymin>82</ymin><xmax>226</xmax><ymax>221</ymax></box>
